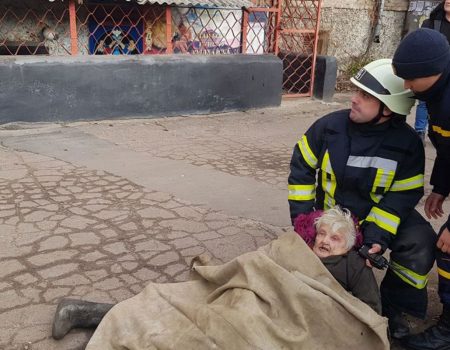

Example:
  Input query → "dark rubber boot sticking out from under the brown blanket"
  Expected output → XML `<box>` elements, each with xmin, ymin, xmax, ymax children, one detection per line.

<box><xmin>52</xmin><ymin>299</ymin><xmax>114</xmax><ymax>339</ymax></box>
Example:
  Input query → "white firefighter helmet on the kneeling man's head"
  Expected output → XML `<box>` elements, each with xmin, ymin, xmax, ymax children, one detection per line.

<box><xmin>350</xmin><ymin>58</ymin><xmax>415</xmax><ymax>115</ymax></box>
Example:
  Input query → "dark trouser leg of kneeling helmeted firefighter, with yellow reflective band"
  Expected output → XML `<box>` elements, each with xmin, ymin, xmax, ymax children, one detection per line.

<box><xmin>380</xmin><ymin>210</ymin><xmax>437</xmax><ymax>318</ymax></box>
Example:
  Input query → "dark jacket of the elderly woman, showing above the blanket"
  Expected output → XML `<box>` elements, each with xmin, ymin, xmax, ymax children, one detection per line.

<box><xmin>321</xmin><ymin>250</ymin><xmax>381</xmax><ymax>314</ymax></box>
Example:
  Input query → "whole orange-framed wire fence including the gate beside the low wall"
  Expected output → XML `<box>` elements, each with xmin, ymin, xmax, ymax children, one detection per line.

<box><xmin>0</xmin><ymin>0</ymin><xmax>320</xmax><ymax>95</ymax></box>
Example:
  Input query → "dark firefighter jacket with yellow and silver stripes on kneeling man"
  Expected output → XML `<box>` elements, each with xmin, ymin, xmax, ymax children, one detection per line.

<box><xmin>288</xmin><ymin>110</ymin><xmax>425</xmax><ymax>250</ymax></box>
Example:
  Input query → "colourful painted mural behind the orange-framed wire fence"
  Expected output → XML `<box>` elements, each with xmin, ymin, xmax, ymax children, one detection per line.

<box><xmin>89</xmin><ymin>7</ymin><xmax>267</xmax><ymax>55</ymax></box>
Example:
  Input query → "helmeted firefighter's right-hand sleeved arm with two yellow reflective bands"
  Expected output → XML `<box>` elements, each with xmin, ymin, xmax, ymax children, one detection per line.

<box><xmin>362</xmin><ymin>138</ymin><xmax>425</xmax><ymax>253</ymax></box>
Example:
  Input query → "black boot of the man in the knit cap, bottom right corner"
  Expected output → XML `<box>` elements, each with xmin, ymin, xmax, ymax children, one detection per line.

<box><xmin>402</xmin><ymin>305</ymin><xmax>450</xmax><ymax>350</ymax></box>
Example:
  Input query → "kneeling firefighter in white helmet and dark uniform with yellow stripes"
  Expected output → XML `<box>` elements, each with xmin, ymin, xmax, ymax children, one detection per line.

<box><xmin>288</xmin><ymin>59</ymin><xmax>436</xmax><ymax>338</ymax></box>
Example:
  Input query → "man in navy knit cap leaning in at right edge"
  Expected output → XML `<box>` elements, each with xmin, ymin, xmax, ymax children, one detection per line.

<box><xmin>393</xmin><ymin>27</ymin><xmax>450</xmax><ymax>350</ymax></box>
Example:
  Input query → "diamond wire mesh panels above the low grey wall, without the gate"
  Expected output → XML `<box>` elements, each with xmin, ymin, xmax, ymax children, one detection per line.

<box><xmin>0</xmin><ymin>0</ymin><xmax>274</xmax><ymax>55</ymax></box>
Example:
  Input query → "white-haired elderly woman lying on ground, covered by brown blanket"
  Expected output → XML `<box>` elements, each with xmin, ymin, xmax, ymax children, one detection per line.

<box><xmin>52</xmin><ymin>207</ymin><xmax>388</xmax><ymax>349</ymax></box>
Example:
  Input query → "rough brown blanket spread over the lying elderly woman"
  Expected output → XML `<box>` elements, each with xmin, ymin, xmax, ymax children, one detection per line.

<box><xmin>86</xmin><ymin>233</ymin><xmax>389</xmax><ymax>350</ymax></box>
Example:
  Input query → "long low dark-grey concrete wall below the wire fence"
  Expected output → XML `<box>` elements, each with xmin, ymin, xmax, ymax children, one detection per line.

<box><xmin>0</xmin><ymin>55</ymin><xmax>282</xmax><ymax>123</ymax></box>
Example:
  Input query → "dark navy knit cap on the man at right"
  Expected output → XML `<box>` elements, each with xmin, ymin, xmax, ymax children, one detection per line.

<box><xmin>392</xmin><ymin>28</ymin><xmax>450</xmax><ymax>80</ymax></box>
